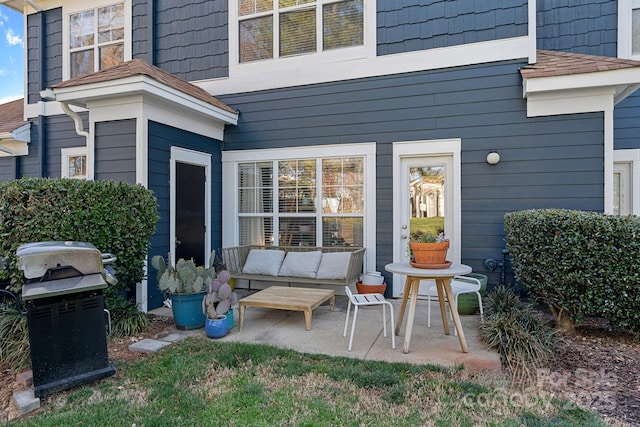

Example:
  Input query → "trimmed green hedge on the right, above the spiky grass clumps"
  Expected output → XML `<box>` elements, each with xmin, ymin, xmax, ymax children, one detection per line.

<box><xmin>505</xmin><ymin>209</ymin><xmax>640</xmax><ymax>333</ymax></box>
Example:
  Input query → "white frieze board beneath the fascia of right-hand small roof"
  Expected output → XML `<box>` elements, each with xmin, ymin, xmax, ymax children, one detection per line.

<box><xmin>527</xmin><ymin>86</ymin><xmax>615</xmax><ymax>117</ymax></box>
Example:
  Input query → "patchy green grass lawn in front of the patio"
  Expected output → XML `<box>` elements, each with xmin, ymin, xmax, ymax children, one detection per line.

<box><xmin>6</xmin><ymin>337</ymin><xmax>604</xmax><ymax>426</ymax></box>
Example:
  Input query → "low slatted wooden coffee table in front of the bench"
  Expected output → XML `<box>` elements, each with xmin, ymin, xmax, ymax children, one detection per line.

<box><xmin>240</xmin><ymin>286</ymin><xmax>336</xmax><ymax>332</ymax></box>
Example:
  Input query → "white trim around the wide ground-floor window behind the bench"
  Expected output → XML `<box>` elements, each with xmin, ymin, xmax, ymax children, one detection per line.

<box><xmin>222</xmin><ymin>142</ymin><xmax>376</xmax><ymax>271</ymax></box>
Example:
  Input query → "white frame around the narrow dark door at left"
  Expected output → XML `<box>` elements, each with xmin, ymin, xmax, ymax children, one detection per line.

<box><xmin>169</xmin><ymin>147</ymin><xmax>211</xmax><ymax>265</ymax></box>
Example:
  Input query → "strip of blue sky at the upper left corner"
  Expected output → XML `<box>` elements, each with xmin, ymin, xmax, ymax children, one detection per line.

<box><xmin>0</xmin><ymin>6</ymin><xmax>24</xmax><ymax>104</ymax></box>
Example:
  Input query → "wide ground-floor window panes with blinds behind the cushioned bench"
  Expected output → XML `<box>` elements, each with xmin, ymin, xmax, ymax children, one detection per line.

<box><xmin>237</xmin><ymin>156</ymin><xmax>365</xmax><ymax>246</ymax></box>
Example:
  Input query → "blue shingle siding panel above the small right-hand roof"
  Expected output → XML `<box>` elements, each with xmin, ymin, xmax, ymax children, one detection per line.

<box><xmin>536</xmin><ymin>0</ymin><xmax>618</xmax><ymax>57</ymax></box>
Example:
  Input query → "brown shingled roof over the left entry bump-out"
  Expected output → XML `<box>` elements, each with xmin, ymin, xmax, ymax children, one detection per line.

<box><xmin>51</xmin><ymin>59</ymin><xmax>237</xmax><ymax>114</ymax></box>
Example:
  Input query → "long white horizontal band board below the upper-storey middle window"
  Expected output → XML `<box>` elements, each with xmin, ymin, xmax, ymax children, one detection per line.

<box><xmin>198</xmin><ymin>36</ymin><xmax>530</xmax><ymax>95</ymax></box>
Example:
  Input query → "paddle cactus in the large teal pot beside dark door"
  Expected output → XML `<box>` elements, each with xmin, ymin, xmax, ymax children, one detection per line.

<box><xmin>151</xmin><ymin>255</ymin><xmax>216</xmax><ymax>329</ymax></box>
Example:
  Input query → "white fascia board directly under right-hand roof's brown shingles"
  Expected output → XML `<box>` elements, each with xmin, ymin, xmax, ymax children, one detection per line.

<box><xmin>522</xmin><ymin>68</ymin><xmax>640</xmax><ymax>98</ymax></box>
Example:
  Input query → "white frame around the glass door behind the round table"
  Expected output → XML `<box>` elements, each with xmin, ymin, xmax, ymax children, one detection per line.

<box><xmin>392</xmin><ymin>138</ymin><xmax>462</xmax><ymax>297</ymax></box>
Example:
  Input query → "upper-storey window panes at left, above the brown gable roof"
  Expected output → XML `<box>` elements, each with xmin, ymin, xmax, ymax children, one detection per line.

<box><xmin>68</xmin><ymin>3</ymin><xmax>128</xmax><ymax>78</ymax></box>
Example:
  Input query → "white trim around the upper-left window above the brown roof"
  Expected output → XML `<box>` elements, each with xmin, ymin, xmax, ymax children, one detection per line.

<box><xmin>62</xmin><ymin>0</ymin><xmax>132</xmax><ymax>80</ymax></box>
